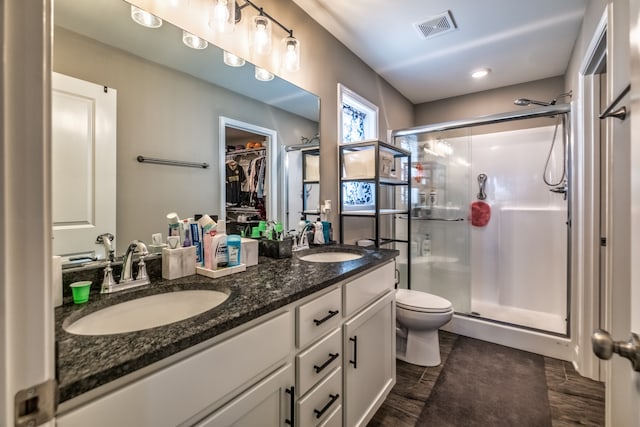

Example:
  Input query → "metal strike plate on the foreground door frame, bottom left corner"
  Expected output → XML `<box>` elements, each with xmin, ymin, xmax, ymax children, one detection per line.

<box><xmin>14</xmin><ymin>380</ymin><xmax>58</xmax><ymax>427</ymax></box>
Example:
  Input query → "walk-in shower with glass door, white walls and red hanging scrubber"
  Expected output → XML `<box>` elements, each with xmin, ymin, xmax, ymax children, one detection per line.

<box><xmin>393</xmin><ymin>103</ymin><xmax>571</xmax><ymax>362</ymax></box>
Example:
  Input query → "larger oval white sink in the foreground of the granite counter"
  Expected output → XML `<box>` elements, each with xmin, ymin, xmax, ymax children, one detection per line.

<box><xmin>63</xmin><ymin>290</ymin><xmax>229</xmax><ymax>335</ymax></box>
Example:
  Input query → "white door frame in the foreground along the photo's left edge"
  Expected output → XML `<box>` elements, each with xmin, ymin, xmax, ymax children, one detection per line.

<box><xmin>0</xmin><ymin>0</ymin><xmax>55</xmax><ymax>426</ymax></box>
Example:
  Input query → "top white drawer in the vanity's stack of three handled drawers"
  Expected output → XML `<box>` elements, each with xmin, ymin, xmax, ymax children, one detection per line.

<box><xmin>296</xmin><ymin>288</ymin><xmax>342</xmax><ymax>348</ymax></box>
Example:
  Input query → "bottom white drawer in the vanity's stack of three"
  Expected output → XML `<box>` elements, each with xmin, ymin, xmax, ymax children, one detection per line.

<box><xmin>296</xmin><ymin>368</ymin><xmax>342</xmax><ymax>427</ymax></box>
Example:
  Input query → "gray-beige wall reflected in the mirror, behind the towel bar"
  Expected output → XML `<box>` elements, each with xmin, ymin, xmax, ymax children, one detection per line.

<box><xmin>53</xmin><ymin>27</ymin><xmax>318</xmax><ymax>253</ymax></box>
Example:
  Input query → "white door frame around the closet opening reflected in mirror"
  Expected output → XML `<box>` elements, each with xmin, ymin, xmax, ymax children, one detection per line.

<box><xmin>218</xmin><ymin>116</ymin><xmax>282</xmax><ymax>221</ymax></box>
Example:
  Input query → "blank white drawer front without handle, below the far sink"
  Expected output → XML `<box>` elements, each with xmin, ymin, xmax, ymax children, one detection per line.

<box><xmin>342</xmin><ymin>262</ymin><xmax>395</xmax><ymax>317</ymax></box>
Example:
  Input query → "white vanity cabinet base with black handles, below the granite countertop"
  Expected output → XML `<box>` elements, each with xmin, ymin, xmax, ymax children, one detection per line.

<box><xmin>56</xmin><ymin>262</ymin><xmax>395</xmax><ymax>427</ymax></box>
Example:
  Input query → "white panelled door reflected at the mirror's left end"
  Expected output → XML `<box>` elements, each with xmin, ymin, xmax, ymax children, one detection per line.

<box><xmin>51</xmin><ymin>73</ymin><xmax>117</xmax><ymax>258</ymax></box>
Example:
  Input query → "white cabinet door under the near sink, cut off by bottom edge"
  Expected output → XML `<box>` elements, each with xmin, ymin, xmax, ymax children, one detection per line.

<box><xmin>196</xmin><ymin>364</ymin><xmax>294</xmax><ymax>427</ymax></box>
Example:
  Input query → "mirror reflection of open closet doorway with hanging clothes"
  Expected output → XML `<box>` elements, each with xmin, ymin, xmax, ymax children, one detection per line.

<box><xmin>222</xmin><ymin>119</ymin><xmax>277</xmax><ymax>227</ymax></box>
